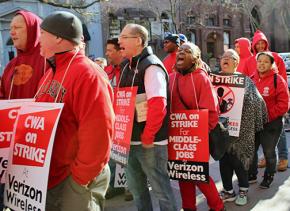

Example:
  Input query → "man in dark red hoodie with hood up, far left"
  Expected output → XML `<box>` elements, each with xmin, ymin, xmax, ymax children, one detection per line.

<box><xmin>0</xmin><ymin>10</ymin><xmax>45</xmax><ymax>210</ymax></box>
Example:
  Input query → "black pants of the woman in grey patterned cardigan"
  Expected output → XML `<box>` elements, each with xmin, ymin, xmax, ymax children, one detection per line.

<box><xmin>220</xmin><ymin>153</ymin><xmax>249</xmax><ymax>191</ymax></box>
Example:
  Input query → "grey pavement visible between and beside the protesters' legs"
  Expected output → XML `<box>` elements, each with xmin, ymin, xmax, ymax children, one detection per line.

<box><xmin>105</xmin><ymin>133</ymin><xmax>290</xmax><ymax>211</ymax></box>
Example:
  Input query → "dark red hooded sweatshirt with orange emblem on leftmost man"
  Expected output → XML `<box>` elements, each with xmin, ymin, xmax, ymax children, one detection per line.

<box><xmin>0</xmin><ymin>11</ymin><xmax>45</xmax><ymax>99</ymax></box>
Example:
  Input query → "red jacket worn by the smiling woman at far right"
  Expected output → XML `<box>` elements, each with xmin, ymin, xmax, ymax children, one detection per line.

<box><xmin>252</xmin><ymin>70</ymin><xmax>289</xmax><ymax>122</ymax></box>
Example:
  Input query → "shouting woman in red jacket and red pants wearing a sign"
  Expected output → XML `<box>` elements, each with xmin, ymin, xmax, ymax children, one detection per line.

<box><xmin>170</xmin><ymin>43</ymin><xmax>224</xmax><ymax>211</ymax></box>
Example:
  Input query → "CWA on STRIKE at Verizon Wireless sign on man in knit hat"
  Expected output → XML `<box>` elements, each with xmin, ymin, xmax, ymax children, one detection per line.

<box><xmin>4</xmin><ymin>102</ymin><xmax>64</xmax><ymax>211</ymax></box>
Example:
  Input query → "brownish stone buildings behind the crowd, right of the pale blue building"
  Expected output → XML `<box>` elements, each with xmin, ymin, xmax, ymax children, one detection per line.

<box><xmin>101</xmin><ymin>0</ymin><xmax>290</xmax><ymax>67</ymax></box>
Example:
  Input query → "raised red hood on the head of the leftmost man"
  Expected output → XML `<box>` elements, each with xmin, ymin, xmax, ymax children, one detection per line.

<box><xmin>16</xmin><ymin>10</ymin><xmax>42</xmax><ymax>54</ymax></box>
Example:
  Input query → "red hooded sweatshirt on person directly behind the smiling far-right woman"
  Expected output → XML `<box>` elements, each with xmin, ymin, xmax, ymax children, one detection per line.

<box><xmin>243</xmin><ymin>30</ymin><xmax>287</xmax><ymax>81</ymax></box>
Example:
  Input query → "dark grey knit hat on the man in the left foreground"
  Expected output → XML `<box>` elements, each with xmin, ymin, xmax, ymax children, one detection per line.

<box><xmin>40</xmin><ymin>11</ymin><xmax>83</xmax><ymax>44</ymax></box>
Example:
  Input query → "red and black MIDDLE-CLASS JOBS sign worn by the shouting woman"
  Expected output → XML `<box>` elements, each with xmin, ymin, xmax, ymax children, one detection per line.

<box><xmin>168</xmin><ymin>109</ymin><xmax>209</xmax><ymax>182</ymax></box>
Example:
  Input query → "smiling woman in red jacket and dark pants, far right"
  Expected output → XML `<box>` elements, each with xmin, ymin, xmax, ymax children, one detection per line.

<box><xmin>249</xmin><ymin>52</ymin><xmax>289</xmax><ymax>188</ymax></box>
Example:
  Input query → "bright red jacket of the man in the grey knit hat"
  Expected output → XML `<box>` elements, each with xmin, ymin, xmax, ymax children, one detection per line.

<box><xmin>36</xmin><ymin>51</ymin><xmax>114</xmax><ymax>188</ymax></box>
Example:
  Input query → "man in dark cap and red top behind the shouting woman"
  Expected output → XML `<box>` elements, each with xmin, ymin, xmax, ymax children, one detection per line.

<box><xmin>163</xmin><ymin>34</ymin><xmax>180</xmax><ymax>74</ymax></box>
